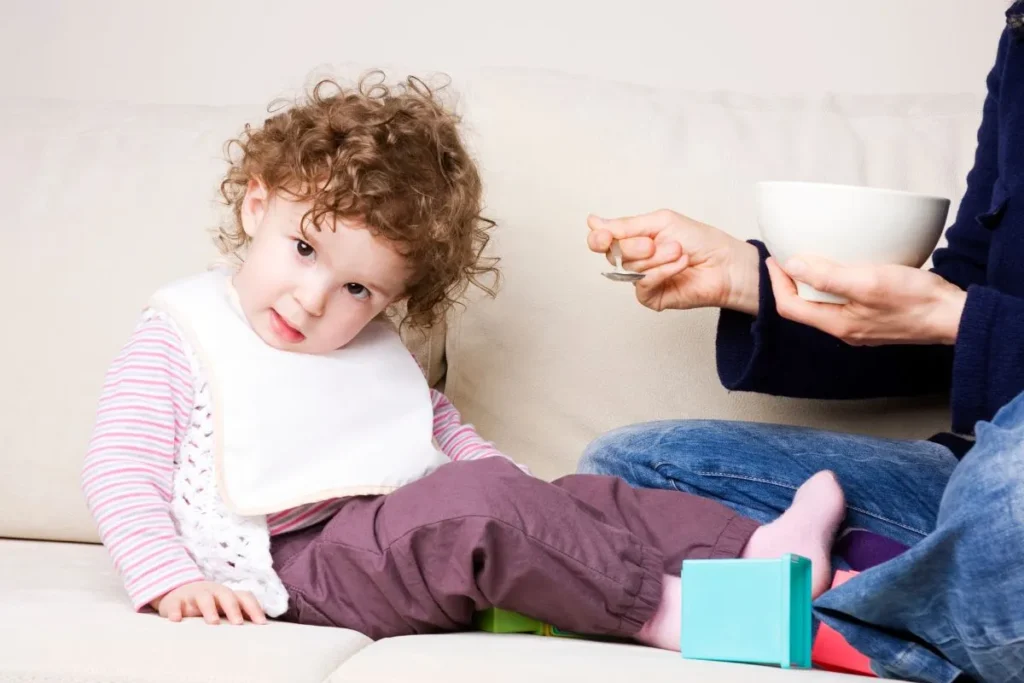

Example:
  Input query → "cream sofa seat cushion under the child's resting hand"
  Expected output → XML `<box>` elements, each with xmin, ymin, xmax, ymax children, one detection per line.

<box><xmin>0</xmin><ymin>541</ymin><xmax>371</xmax><ymax>683</ymax></box>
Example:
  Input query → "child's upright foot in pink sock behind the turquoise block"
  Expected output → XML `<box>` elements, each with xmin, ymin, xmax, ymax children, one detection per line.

<box><xmin>741</xmin><ymin>472</ymin><xmax>846</xmax><ymax>598</ymax></box>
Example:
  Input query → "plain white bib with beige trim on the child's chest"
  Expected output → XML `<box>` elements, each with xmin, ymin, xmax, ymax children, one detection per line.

<box><xmin>150</xmin><ymin>270</ymin><xmax>447</xmax><ymax>516</ymax></box>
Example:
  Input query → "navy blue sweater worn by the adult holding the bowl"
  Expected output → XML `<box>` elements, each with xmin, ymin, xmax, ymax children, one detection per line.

<box><xmin>717</xmin><ymin>25</ymin><xmax>1024</xmax><ymax>455</ymax></box>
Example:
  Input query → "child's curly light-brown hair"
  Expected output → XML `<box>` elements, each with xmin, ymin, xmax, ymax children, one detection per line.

<box><xmin>217</xmin><ymin>72</ymin><xmax>499</xmax><ymax>328</ymax></box>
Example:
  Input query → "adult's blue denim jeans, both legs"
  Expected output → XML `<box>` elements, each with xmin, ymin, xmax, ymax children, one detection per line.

<box><xmin>580</xmin><ymin>394</ymin><xmax>1024</xmax><ymax>683</ymax></box>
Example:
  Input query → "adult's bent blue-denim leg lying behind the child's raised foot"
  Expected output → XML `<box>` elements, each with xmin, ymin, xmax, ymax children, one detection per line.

<box><xmin>579</xmin><ymin>420</ymin><xmax>957</xmax><ymax>545</ymax></box>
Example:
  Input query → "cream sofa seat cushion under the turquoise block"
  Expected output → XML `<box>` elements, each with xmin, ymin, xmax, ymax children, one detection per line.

<box><xmin>331</xmin><ymin>633</ymin><xmax>857</xmax><ymax>683</ymax></box>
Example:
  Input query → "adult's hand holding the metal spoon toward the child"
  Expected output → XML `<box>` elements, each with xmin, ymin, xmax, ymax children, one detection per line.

<box><xmin>587</xmin><ymin>210</ymin><xmax>760</xmax><ymax>315</ymax></box>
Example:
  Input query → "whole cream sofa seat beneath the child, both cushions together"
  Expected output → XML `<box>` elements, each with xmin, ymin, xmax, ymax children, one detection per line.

<box><xmin>0</xmin><ymin>541</ymin><xmax>872</xmax><ymax>683</ymax></box>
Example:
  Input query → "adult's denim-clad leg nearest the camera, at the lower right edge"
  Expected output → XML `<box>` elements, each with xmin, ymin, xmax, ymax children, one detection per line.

<box><xmin>815</xmin><ymin>394</ymin><xmax>1024</xmax><ymax>683</ymax></box>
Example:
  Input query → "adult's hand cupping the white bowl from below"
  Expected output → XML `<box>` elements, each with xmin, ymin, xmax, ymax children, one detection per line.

<box><xmin>768</xmin><ymin>256</ymin><xmax>967</xmax><ymax>346</ymax></box>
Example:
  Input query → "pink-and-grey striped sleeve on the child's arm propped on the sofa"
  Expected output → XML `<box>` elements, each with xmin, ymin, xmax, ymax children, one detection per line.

<box><xmin>82</xmin><ymin>313</ymin><xmax>204</xmax><ymax>609</ymax></box>
